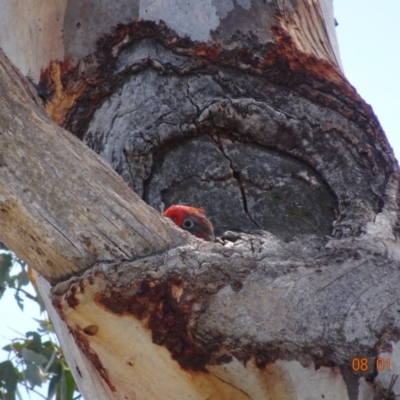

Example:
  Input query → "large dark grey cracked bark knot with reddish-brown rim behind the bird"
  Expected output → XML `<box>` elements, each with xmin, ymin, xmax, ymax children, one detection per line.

<box><xmin>40</xmin><ymin>22</ymin><xmax>391</xmax><ymax>240</ymax></box>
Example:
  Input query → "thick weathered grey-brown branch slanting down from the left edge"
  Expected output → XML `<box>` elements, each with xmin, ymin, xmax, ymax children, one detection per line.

<box><xmin>0</xmin><ymin>49</ymin><xmax>188</xmax><ymax>282</ymax></box>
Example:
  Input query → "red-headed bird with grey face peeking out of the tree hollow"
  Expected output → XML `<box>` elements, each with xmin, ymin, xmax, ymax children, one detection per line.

<box><xmin>164</xmin><ymin>204</ymin><xmax>214</xmax><ymax>242</ymax></box>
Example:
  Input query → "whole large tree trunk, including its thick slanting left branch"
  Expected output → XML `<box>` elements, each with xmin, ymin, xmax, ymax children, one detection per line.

<box><xmin>0</xmin><ymin>0</ymin><xmax>400</xmax><ymax>400</ymax></box>
